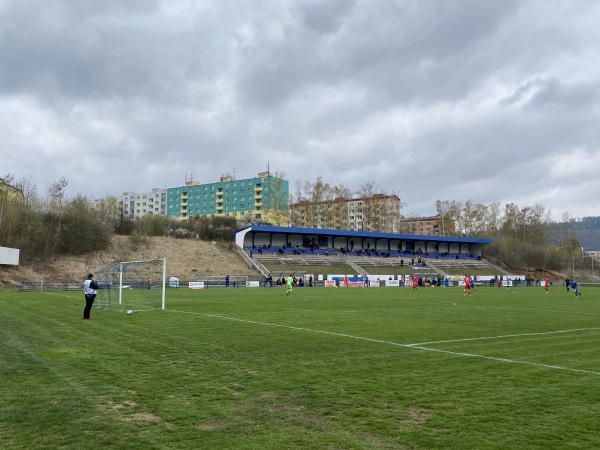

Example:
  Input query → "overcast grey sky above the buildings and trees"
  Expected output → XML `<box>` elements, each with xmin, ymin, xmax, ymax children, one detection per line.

<box><xmin>0</xmin><ymin>0</ymin><xmax>600</xmax><ymax>220</ymax></box>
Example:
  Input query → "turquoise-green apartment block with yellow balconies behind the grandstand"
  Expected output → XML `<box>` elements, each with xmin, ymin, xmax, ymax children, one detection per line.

<box><xmin>167</xmin><ymin>172</ymin><xmax>289</xmax><ymax>226</ymax></box>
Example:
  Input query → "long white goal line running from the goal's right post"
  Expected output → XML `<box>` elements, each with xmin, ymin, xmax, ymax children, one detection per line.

<box><xmin>165</xmin><ymin>309</ymin><xmax>600</xmax><ymax>376</ymax></box>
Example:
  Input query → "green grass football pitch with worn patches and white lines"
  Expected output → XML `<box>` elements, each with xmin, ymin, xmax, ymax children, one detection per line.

<box><xmin>0</xmin><ymin>287</ymin><xmax>600</xmax><ymax>449</ymax></box>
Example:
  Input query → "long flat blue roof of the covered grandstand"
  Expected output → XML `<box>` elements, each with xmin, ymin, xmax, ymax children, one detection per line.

<box><xmin>237</xmin><ymin>225</ymin><xmax>493</xmax><ymax>244</ymax></box>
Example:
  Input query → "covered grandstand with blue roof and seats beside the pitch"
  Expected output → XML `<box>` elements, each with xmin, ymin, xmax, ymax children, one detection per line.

<box><xmin>235</xmin><ymin>225</ymin><xmax>505</xmax><ymax>277</ymax></box>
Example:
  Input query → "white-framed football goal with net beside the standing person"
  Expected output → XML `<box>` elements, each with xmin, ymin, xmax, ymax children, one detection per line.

<box><xmin>93</xmin><ymin>259</ymin><xmax>167</xmax><ymax>311</ymax></box>
